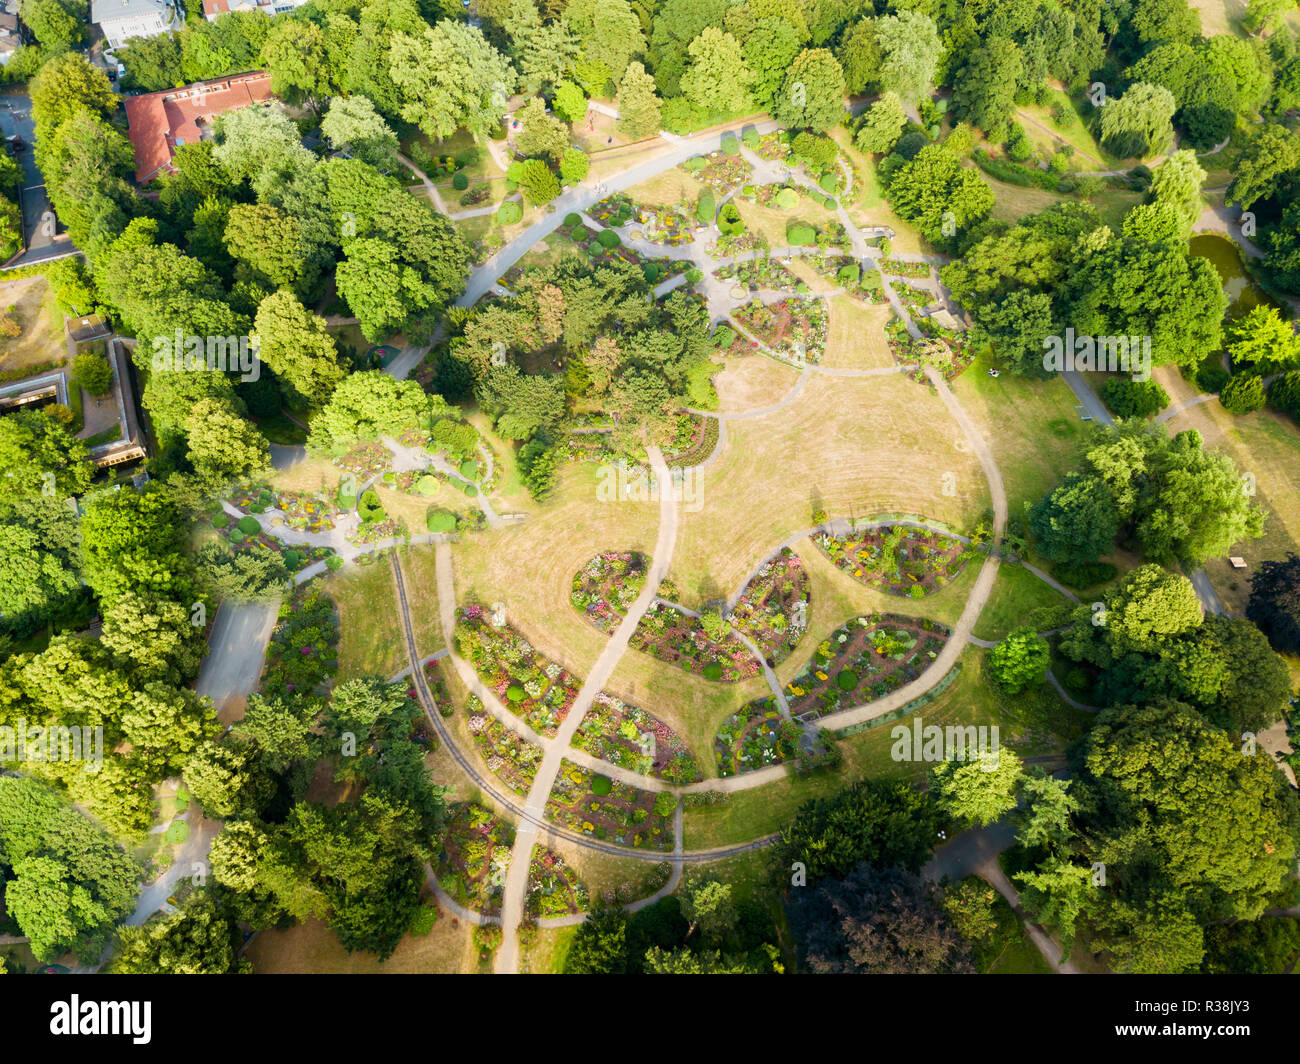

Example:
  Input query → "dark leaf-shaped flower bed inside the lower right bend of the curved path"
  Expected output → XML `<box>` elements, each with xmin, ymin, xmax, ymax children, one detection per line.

<box><xmin>785</xmin><ymin>614</ymin><xmax>952</xmax><ymax>721</ymax></box>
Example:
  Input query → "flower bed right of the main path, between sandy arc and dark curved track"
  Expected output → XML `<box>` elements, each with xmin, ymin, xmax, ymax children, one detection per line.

<box><xmin>546</xmin><ymin>761</ymin><xmax>677</xmax><ymax>849</ymax></box>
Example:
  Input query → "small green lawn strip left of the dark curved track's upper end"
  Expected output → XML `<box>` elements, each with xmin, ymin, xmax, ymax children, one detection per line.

<box><xmin>325</xmin><ymin>559</ymin><xmax>410</xmax><ymax>680</ymax></box>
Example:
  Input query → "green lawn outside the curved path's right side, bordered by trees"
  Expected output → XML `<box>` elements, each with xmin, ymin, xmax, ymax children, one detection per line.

<box><xmin>953</xmin><ymin>354</ymin><xmax>1088</xmax><ymax>516</ymax></box>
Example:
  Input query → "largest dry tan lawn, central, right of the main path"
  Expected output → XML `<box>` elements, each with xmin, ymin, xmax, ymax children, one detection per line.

<box><xmin>668</xmin><ymin>373</ymin><xmax>989</xmax><ymax>601</ymax></box>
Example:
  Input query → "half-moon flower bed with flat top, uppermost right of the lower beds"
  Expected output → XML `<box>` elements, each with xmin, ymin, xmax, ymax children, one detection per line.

<box><xmin>813</xmin><ymin>524</ymin><xmax>974</xmax><ymax>598</ymax></box>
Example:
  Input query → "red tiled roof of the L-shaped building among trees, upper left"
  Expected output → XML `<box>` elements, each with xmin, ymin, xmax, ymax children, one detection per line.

<box><xmin>125</xmin><ymin>70</ymin><xmax>273</xmax><ymax>185</ymax></box>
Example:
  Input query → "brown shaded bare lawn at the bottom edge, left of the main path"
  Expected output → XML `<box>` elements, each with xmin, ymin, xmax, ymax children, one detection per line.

<box><xmin>244</xmin><ymin>912</ymin><xmax>478</xmax><ymax>974</ymax></box>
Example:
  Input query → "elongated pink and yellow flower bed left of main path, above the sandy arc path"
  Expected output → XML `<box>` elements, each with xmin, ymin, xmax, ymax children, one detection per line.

<box><xmin>456</xmin><ymin>605</ymin><xmax>581</xmax><ymax>738</ymax></box>
